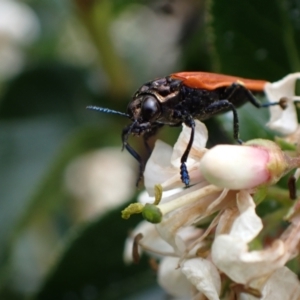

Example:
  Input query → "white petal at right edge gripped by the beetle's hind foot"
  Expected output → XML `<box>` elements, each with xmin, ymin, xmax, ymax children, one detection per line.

<box><xmin>265</xmin><ymin>73</ymin><xmax>300</xmax><ymax>135</ymax></box>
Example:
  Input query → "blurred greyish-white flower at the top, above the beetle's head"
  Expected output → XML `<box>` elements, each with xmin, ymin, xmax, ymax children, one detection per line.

<box><xmin>111</xmin><ymin>5</ymin><xmax>182</xmax><ymax>78</ymax></box>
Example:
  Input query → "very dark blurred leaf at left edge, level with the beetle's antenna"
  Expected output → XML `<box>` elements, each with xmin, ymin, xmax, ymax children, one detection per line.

<box><xmin>0</xmin><ymin>61</ymin><xmax>93</xmax><ymax>120</ymax></box>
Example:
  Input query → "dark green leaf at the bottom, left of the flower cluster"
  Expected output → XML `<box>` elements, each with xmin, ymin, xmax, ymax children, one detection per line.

<box><xmin>34</xmin><ymin>202</ymin><xmax>155</xmax><ymax>300</ymax></box>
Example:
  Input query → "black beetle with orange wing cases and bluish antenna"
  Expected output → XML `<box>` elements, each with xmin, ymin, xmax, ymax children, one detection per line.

<box><xmin>87</xmin><ymin>72</ymin><xmax>279</xmax><ymax>186</ymax></box>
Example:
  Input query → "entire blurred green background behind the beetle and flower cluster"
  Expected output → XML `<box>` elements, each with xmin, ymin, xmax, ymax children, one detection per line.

<box><xmin>0</xmin><ymin>0</ymin><xmax>300</xmax><ymax>300</ymax></box>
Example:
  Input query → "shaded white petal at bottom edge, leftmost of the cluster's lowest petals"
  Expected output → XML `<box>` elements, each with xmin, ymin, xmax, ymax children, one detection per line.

<box><xmin>158</xmin><ymin>257</ymin><xmax>192</xmax><ymax>299</ymax></box>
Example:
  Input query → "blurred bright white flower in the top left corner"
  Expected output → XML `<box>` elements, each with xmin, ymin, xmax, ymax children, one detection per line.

<box><xmin>0</xmin><ymin>0</ymin><xmax>40</xmax><ymax>80</ymax></box>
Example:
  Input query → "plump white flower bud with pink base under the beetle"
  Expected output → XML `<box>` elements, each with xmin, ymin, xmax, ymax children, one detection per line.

<box><xmin>200</xmin><ymin>139</ymin><xmax>288</xmax><ymax>190</ymax></box>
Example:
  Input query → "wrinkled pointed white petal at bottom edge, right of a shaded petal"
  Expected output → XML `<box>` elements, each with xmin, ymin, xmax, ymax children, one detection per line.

<box><xmin>181</xmin><ymin>258</ymin><xmax>221</xmax><ymax>300</ymax></box>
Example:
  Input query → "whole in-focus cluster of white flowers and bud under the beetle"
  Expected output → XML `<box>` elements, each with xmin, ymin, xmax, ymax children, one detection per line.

<box><xmin>123</xmin><ymin>73</ymin><xmax>300</xmax><ymax>300</ymax></box>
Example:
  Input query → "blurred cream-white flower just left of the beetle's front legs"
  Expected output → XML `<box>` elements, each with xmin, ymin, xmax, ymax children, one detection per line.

<box><xmin>65</xmin><ymin>148</ymin><xmax>136</xmax><ymax>220</ymax></box>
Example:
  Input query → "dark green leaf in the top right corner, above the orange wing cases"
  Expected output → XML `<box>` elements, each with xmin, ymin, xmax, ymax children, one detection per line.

<box><xmin>208</xmin><ymin>0</ymin><xmax>300</xmax><ymax>81</ymax></box>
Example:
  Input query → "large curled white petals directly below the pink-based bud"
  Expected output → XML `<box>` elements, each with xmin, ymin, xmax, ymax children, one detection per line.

<box><xmin>212</xmin><ymin>191</ymin><xmax>270</xmax><ymax>284</ymax></box>
